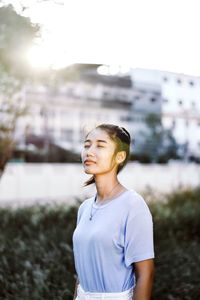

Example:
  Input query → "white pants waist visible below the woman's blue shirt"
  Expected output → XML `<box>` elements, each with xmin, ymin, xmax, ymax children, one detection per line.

<box><xmin>75</xmin><ymin>283</ymin><xmax>133</xmax><ymax>300</ymax></box>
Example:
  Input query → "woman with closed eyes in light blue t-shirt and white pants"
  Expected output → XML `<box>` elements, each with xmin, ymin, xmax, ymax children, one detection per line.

<box><xmin>73</xmin><ymin>124</ymin><xmax>154</xmax><ymax>300</ymax></box>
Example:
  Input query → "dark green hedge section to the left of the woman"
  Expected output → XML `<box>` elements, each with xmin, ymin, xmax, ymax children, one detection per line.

<box><xmin>0</xmin><ymin>206</ymin><xmax>76</xmax><ymax>300</ymax></box>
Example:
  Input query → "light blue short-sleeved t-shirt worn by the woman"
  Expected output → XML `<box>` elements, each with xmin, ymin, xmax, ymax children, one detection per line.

<box><xmin>72</xmin><ymin>189</ymin><xmax>154</xmax><ymax>293</ymax></box>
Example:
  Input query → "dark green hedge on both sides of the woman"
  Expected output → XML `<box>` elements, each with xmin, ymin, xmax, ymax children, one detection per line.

<box><xmin>0</xmin><ymin>188</ymin><xmax>200</xmax><ymax>300</ymax></box>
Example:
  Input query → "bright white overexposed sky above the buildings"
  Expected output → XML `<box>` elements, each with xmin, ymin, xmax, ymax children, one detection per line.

<box><xmin>3</xmin><ymin>0</ymin><xmax>200</xmax><ymax>76</ymax></box>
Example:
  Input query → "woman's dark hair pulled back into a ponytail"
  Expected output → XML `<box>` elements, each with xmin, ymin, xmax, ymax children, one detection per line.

<box><xmin>84</xmin><ymin>123</ymin><xmax>131</xmax><ymax>186</ymax></box>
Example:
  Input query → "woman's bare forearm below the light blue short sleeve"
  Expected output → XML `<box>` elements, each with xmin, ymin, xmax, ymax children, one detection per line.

<box><xmin>133</xmin><ymin>259</ymin><xmax>154</xmax><ymax>300</ymax></box>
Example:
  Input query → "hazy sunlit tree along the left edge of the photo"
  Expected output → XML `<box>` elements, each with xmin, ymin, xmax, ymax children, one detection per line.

<box><xmin>0</xmin><ymin>5</ymin><xmax>39</xmax><ymax>177</ymax></box>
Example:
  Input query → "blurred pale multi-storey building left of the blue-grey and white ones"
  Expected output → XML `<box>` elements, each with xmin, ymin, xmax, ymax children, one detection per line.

<box><xmin>15</xmin><ymin>65</ymin><xmax>133</xmax><ymax>152</ymax></box>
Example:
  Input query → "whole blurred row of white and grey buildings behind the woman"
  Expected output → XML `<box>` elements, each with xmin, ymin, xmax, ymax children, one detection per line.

<box><xmin>12</xmin><ymin>65</ymin><xmax>200</xmax><ymax>158</ymax></box>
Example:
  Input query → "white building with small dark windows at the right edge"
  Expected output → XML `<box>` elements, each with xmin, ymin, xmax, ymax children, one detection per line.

<box><xmin>131</xmin><ymin>69</ymin><xmax>200</xmax><ymax>156</ymax></box>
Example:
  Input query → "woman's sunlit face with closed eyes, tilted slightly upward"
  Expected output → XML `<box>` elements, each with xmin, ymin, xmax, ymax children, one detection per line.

<box><xmin>81</xmin><ymin>128</ymin><xmax>117</xmax><ymax>175</ymax></box>
